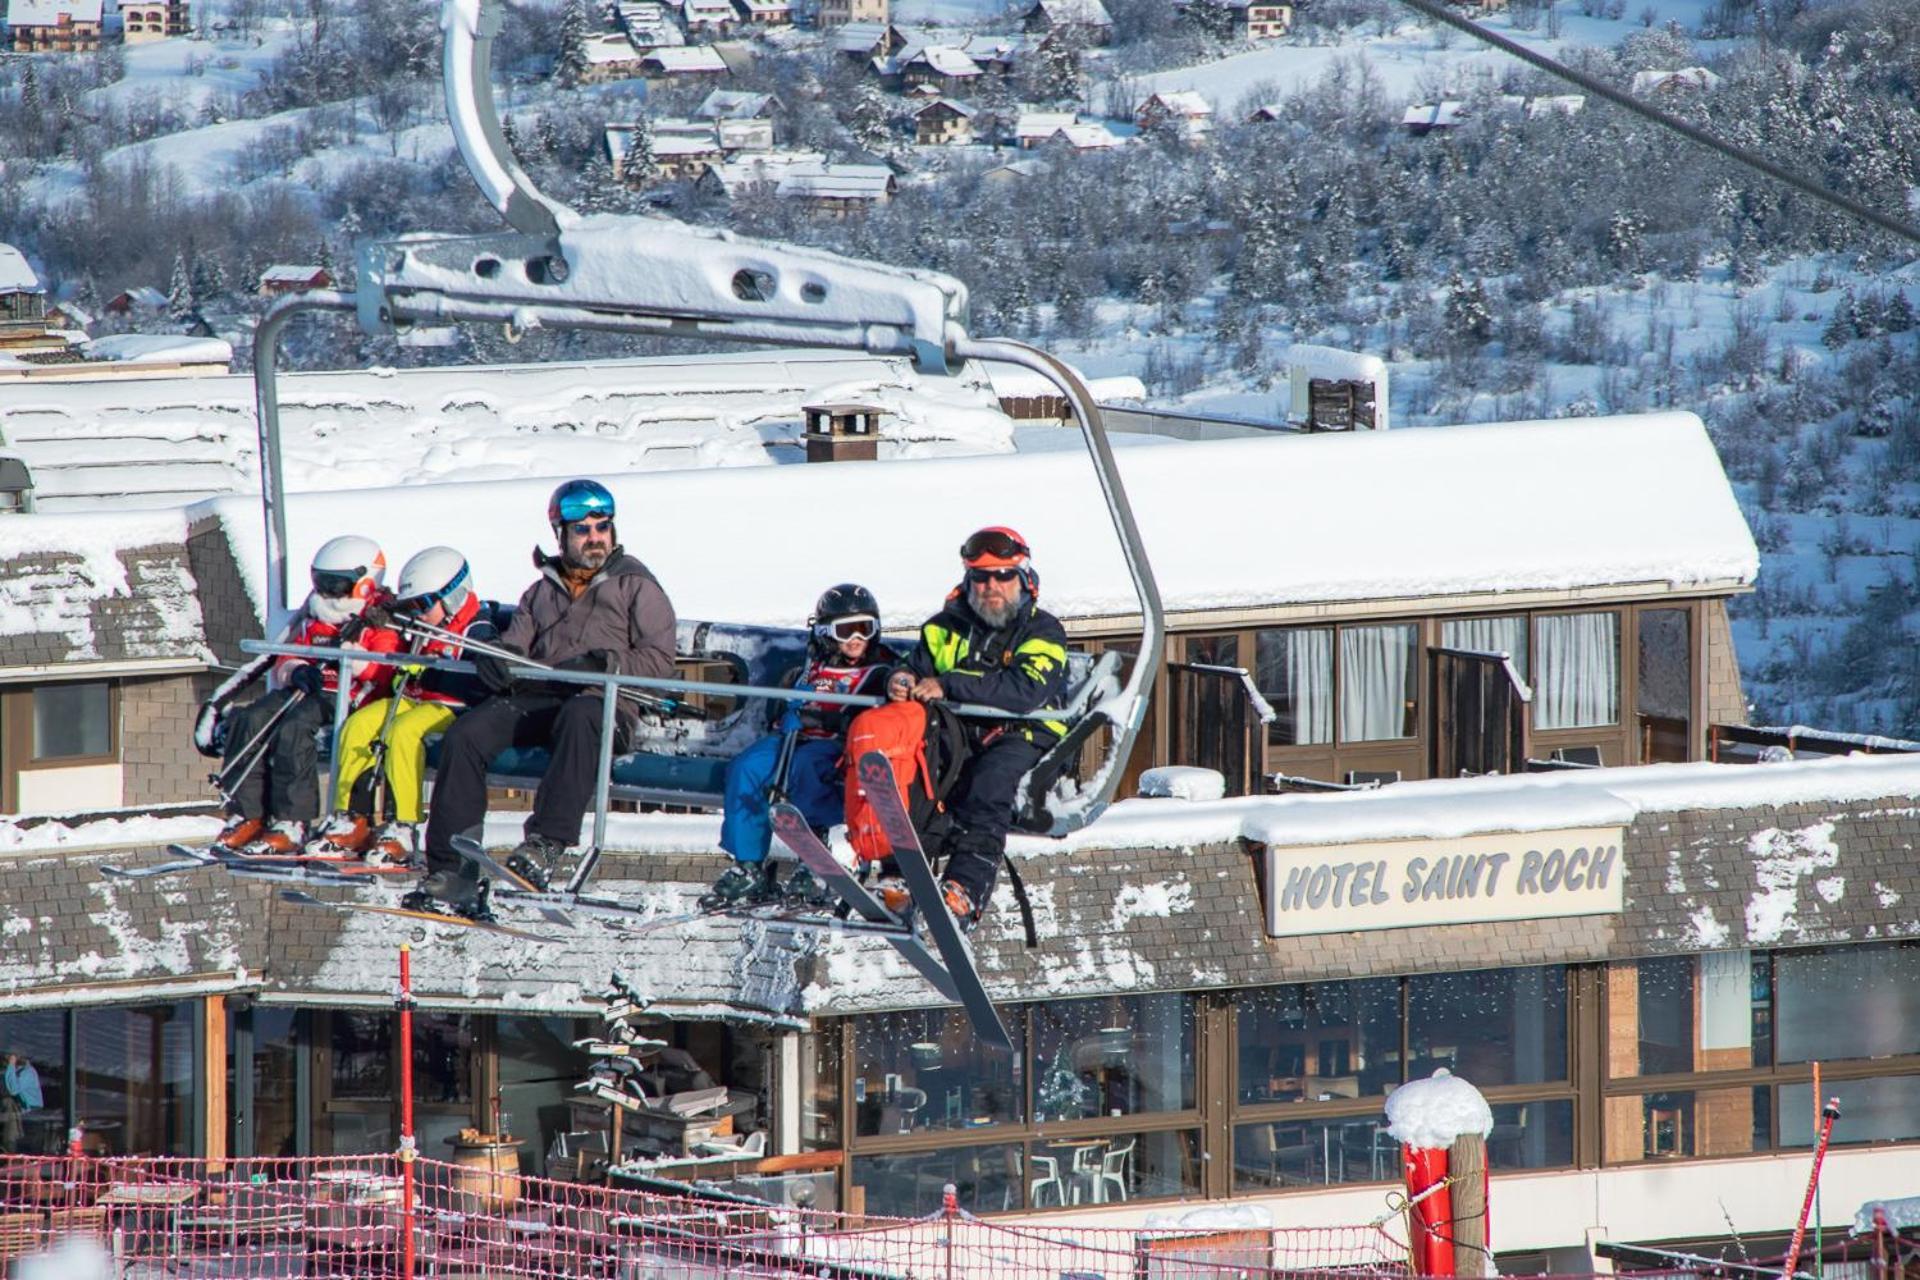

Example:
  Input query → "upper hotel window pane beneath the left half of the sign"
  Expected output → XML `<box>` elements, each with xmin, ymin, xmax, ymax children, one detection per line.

<box><xmin>1238</xmin><ymin>979</ymin><xmax>1400</xmax><ymax>1102</ymax></box>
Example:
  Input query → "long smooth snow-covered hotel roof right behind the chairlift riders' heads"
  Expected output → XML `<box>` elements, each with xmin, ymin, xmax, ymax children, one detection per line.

<box><xmin>210</xmin><ymin>410</ymin><xmax>1759</xmax><ymax>626</ymax></box>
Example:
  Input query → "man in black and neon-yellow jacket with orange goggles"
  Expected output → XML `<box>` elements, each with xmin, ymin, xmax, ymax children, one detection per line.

<box><xmin>887</xmin><ymin>526</ymin><xmax>1068</xmax><ymax>923</ymax></box>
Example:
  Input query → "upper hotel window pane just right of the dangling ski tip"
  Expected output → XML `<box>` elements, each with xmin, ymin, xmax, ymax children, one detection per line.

<box><xmin>1033</xmin><ymin>994</ymin><xmax>1194</xmax><ymax>1125</ymax></box>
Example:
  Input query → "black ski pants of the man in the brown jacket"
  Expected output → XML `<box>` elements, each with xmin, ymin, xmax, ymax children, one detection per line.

<box><xmin>426</xmin><ymin>685</ymin><xmax>630</xmax><ymax>867</ymax></box>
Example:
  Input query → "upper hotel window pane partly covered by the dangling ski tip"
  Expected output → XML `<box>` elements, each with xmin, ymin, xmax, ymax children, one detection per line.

<box><xmin>852</xmin><ymin>1009</ymin><xmax>1025</xmax><ymax>1134</ymax></box>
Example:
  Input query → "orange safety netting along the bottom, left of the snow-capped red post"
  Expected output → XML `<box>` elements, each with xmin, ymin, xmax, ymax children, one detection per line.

<box><xmin>0</xmin><ymin>1155</ymin><xmax>1409</xmax><ymax>1280</ymax></box>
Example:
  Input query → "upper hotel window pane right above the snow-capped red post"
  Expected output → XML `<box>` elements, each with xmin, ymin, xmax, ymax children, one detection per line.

<box><xmin>1407</xmin><ymin>965</ymin><xmax>1567</xmax><ymax>1088</ymax></box>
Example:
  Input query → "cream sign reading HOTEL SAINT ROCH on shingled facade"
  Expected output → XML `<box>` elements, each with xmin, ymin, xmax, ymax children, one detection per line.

<box><xmin>1267</xmin><ymin>827</ymin><xmax>1626</xmax><ymax>938</ymax></box>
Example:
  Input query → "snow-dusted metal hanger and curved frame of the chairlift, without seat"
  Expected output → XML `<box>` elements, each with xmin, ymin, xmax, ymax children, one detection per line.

<box><xmin>253</xmin><ymin>0</ymin><xmax>1165</xmax><ymax>844</ymax></box>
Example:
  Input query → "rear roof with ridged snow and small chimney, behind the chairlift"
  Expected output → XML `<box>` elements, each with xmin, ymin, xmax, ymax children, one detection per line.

<box><xmin>0</xmin><ymin>351</ymin><xmax>1012</xmax><ymax>514</ymax></box>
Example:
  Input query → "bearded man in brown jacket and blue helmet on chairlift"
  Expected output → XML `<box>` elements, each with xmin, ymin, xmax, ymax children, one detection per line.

<box><xmin>417</xmin><ymin>480</ymin><xmax>674</xmax><ymax>912</ymax></box>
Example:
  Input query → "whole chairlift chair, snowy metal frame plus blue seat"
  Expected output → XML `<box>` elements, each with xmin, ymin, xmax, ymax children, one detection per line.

<box><xmin>253</xmin><ymin>0</ymin><xmax>1164</xmax><ymax>859</ymax></box>
